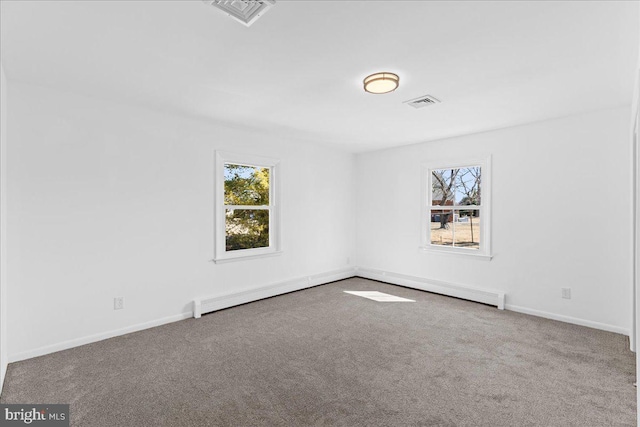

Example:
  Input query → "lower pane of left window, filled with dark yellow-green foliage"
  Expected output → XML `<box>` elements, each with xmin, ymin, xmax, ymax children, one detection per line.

<box><xmin>225</xmin><ymin>209</ymin><xmax>269</xmax><ymax>251</ymax></box>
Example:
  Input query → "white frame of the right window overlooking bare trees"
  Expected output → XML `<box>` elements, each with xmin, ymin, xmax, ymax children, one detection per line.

<box><xmin>420</xmin><ymin>156</ymin><xmax>493</xmax><ymax>260</ymax></box>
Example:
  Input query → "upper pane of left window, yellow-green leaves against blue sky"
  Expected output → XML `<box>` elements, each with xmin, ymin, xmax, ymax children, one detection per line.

<box><xmin>224</xmin><ymin>163</ymin><xmax>270</xmax><ymax>206</ymax></box>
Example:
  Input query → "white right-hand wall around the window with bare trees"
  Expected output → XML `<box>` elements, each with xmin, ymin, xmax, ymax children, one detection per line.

<box><xmin>356</xmin><ymin>108</ymin><xmax>632</xmax><ymax>333</ymax></box>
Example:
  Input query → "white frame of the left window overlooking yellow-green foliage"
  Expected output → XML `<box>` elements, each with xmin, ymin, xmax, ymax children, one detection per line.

<box><xmin>213</xmin><ymin>151</ymin><xmax>282</xmax><ymax>263</ymax></box>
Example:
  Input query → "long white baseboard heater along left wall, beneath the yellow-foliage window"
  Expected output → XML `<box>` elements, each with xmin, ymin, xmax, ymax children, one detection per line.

<box><xmin>193</xmin><ymin>267</ymin><xmax>356</xmax><ymax>319</ymax></box>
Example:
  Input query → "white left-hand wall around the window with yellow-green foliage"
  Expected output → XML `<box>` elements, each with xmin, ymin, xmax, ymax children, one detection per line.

<box><xmin>8</xmin><ymin>80</ymin><xmax>354</xmax><ymax>360</ymax></box>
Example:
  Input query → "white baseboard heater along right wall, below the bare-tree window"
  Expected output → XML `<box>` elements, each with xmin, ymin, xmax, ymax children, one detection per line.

<box><xmin>356</xmin><ymin>268</ymin><xmax>504</xmax><ymax>310</ymax></box>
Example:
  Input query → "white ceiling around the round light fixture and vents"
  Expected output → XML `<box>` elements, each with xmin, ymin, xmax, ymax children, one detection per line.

<box><xmin>0</xmin><ymin>0</ymin><xmax>639</xmax><ymax>152</ymax></box>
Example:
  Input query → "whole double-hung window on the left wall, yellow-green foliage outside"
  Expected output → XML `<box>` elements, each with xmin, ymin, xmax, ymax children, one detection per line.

<box><xmin>215</xmin><ymin>152</ymin><xmax>280</xmax><ymax>262</ymax></box>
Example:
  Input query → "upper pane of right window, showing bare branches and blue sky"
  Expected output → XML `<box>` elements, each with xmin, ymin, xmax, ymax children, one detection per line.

<box><xmin>431</xmin><ymin>166</ymin><xmax>481</xmax><ymax>206</ymax></box>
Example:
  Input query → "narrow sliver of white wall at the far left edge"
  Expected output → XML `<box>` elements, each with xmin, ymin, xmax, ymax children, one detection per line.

<box><xmin>0</xmin><ymin>63</ymin><xmax>8</xmax><ymax>391</ymax></box>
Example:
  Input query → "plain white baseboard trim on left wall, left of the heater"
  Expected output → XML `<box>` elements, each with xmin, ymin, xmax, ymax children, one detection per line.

<box><xmin>9</xmin><ymin>312</ymin><xmax>191</xmax><ymax>363</ymax></box>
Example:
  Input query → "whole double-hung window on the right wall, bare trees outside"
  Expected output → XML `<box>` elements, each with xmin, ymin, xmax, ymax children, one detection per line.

<box><xmin>422</xmin><ymin>159</ymin><xmax>491</xmax><ymax>258</ymax></box>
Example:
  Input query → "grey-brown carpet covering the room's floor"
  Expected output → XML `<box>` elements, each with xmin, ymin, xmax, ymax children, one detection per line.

<box><xmin>0</xmin><ymin>278</ymin><xmax>636</xmax><ymax>427</ymax></box>
